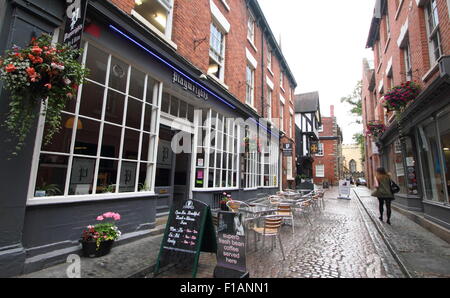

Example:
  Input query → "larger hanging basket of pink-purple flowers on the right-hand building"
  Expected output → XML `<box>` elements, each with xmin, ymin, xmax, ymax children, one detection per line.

<box><xmin>384</xmin><ymin>81</ymin><xmax>420</xmax><ymax>111</ymax></box>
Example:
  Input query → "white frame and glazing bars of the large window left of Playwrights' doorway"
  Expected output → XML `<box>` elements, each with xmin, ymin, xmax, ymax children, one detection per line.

<box><xmin>27</xmin><ymin>39</ymin><xmax>163</xmax><ymax>205</ymax></box>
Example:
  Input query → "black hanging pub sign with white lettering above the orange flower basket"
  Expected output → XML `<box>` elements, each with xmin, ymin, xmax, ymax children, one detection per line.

<box><xmin>63</xmin><ymin>0</ymin><xmax>88</xmax><ymax>49</ymax></box>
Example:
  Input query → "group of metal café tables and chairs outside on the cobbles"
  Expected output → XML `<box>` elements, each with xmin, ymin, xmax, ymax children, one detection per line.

<box><xmin>213</xmin><ymin>188</ymin><xmax>325</xmax><ymax>260</ymax></box>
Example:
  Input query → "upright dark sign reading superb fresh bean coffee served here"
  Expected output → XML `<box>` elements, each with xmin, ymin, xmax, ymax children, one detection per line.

<box><xmin>214</xmin><ymin>211</ymin><xmax>248</xmax><ymax>278</ymax></box>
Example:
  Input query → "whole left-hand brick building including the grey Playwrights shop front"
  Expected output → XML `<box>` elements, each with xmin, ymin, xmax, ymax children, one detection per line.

<box><xmin>0</xmin><ymin>0</ymin><xmax>297</xmax><ymax>276</ymax></box>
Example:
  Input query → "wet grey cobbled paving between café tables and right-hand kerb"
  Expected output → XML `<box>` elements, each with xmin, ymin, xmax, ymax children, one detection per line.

<box><xmin>154</xmin><ymin>189</ymin><xmax>404</xmax><ymax>278</ymax></box>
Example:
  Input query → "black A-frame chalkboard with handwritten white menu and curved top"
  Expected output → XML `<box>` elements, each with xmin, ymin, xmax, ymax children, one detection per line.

<box><xmin>154</xmin><ymin>200</ymin><xmax>217</xmax><ymax>278</ymax></box>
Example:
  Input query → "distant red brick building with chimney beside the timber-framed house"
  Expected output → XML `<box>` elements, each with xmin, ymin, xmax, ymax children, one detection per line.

<box><xmin>312</xmin><ymin>105</ymin><xmax>343</xmax><ymax>185</ymax></box>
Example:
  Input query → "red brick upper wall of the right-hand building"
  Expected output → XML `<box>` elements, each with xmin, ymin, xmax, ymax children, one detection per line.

<box><xmin>362</xmin><ymin>0</ymin><xmax>450</xmax><ymax>186</ymax></box>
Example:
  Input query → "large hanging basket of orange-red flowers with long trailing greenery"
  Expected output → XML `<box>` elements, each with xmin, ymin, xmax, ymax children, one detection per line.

<box><xmin>0</xmin><ymin>34</ymin><xmax>88</xmax><ymax>155</ymax></box>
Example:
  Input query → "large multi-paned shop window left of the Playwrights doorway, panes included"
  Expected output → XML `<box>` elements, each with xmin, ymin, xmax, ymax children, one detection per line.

<box><xmin>31</xmin><ymin>42</ymin><xmax>162</xmax><ymax>197</ymax></box>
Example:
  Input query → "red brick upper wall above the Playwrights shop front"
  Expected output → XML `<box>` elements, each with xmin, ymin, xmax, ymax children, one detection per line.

<box><xmin>110</xmin><ymin>0</ymin><xmax>295</xmax><ymax>186</ymax></box>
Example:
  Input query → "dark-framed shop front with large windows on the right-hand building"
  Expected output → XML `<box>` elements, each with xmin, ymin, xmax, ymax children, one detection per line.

<box><xmin>382</xmin><ymin>60</ymin><xmax>450</xmax><ymax>228</ymax></box>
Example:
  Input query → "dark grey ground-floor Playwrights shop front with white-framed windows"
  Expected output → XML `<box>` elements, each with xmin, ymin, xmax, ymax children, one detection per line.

<box><xmin>0</xmin><ymin>1</ymin><xmax>280</xmax><ymax>276</ymax></box>
